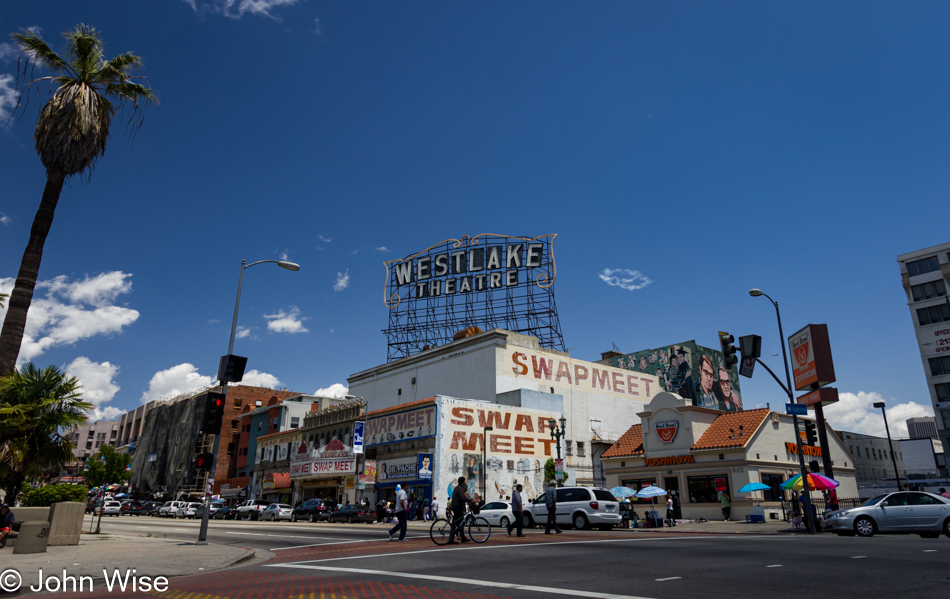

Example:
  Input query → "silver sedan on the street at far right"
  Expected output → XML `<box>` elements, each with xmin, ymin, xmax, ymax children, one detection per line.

<box><xmin>822</xmin><ymin>491</ymin><xmax>950</xmax><ymax>539</ymax></box>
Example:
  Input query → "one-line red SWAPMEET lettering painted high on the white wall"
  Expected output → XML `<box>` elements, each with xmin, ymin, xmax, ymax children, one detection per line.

<box><xmin>504</xmin><ymin>348</ymin><xmax>662</xmax><ymax>401</ymax></box>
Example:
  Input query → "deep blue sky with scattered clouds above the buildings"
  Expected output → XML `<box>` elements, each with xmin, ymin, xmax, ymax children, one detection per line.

<box><xmin>0</xmin><ymin>0</ymin><xmax>950</xmax><ymax>433</ymax></box>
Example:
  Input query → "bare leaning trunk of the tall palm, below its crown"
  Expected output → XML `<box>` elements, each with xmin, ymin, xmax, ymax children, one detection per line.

<box><xmin>0</xmin><ymin>170</ymin><xmax>66</xmax><ymax>376</ymax></box>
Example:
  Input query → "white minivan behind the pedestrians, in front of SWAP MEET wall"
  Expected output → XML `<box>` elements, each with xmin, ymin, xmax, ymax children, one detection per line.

<box><xmin>525</xmin><ymin>487</ymin><xmax>620</xmax><ymax>530</ymax></box>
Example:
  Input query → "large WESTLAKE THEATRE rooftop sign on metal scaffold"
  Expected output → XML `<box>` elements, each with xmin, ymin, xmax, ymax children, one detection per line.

<box><xmin>383</xmin><ymin>233</ymin><xmax>564</xmax><ymax>361</ymax></box>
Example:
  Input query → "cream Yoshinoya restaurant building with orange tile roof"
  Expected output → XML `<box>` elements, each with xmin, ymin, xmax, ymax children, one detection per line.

<box><xmin>602</xmin><ymin>392</ymin><xmax>858</xmax><ymax>520</ymax></box>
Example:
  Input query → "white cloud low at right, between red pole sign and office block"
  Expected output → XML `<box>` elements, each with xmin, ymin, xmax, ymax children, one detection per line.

<box><xmin>824</xmin><ymin>391</ymin><xmax>934</xmax><ymax>439</ymax></box>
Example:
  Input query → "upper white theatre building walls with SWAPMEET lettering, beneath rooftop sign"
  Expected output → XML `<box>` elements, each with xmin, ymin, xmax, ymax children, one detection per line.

<box><xmin>348</xmin><ymin>329</ymin><xmax>661</xmax><ymax>484</ymax></box>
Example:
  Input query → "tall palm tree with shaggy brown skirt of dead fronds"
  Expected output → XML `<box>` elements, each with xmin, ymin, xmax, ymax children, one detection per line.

<box><xmin>0</xmin><ymin>25</ymin><xmax>158</xmax><ymax>375</ymax></box>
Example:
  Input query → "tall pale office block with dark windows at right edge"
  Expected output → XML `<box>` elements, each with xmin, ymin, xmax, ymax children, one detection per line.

<box><xmin>897</xmin><ymin>243</ymin><xmax>950</xmax><ymax>458</ymax></box>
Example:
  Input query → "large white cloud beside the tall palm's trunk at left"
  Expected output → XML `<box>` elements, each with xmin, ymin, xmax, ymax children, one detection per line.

<box><xmin>0</xmin><ymin>271</ymin><xmax>139</xmax><ymax>365</ymax></box>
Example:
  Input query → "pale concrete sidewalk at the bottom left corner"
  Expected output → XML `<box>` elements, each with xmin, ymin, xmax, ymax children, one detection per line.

<box><xmin>0</xmin><ymin>534</ymin><xmax>256</xmax><ymax>597</ymax></box>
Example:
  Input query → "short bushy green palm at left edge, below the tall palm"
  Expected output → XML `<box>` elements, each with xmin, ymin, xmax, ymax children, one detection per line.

<box><xmin>0</xmin><ymin>364</ymin><xmax>93</xmax><ymax>503</ymax></box>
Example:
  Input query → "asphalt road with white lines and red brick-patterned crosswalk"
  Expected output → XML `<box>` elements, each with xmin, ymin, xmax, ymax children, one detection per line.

<box><xmin>91</xmin><ymin>518</ymin><xmax>950</xmax><ymax>599</ymax></box>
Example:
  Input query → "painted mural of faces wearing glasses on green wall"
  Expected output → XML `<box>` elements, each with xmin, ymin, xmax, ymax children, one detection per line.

<box><xmin>610</xmin><ymin>341</ymin><xmax>742</xmax><ymax>412</ymax></box>
